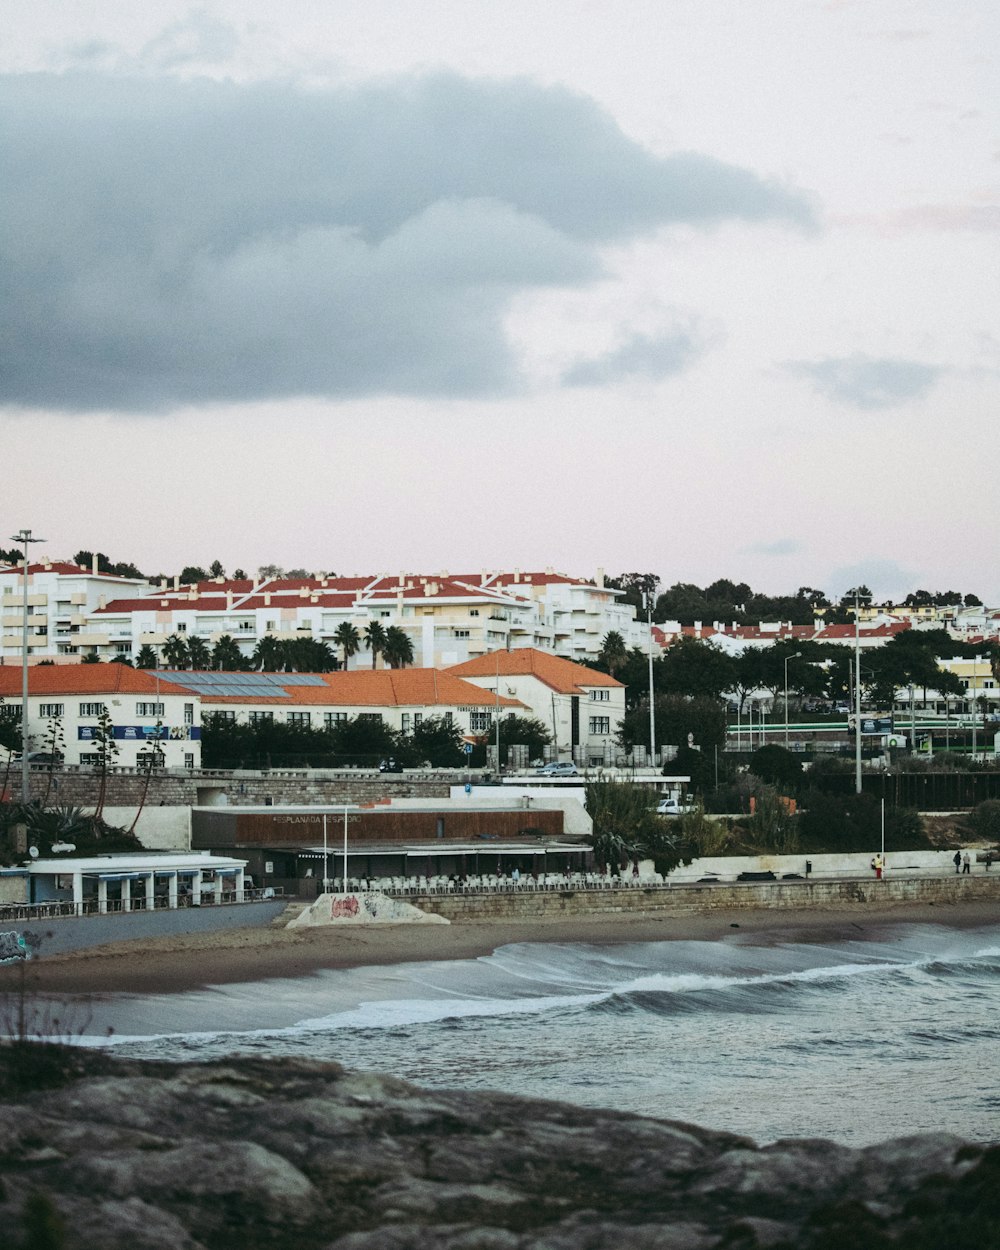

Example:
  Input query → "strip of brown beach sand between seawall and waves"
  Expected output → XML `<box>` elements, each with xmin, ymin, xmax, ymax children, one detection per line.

<box><xmin>0</xmin><ymin>900</ymin><xmax>1000</xmax><ymax>998</ymax></box>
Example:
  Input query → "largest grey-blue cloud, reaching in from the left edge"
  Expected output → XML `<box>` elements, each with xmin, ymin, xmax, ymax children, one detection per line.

<box><xmin>0</xmin><ymin>69</ymin><xmax>810</xmax><ymax>411</ymax></box>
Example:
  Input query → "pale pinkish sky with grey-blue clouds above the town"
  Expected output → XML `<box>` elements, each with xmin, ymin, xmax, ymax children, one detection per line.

<box><xmin>0</xmin><ymin>0</ymin><xmax>1000</xmax><ymax>605</ymax></box>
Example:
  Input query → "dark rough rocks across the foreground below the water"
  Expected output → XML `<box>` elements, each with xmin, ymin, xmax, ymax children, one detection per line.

<box><xmin>0</xmin><ymin>1048</ymin><xmax>1000</xmax><ymax>1250</ymax></box>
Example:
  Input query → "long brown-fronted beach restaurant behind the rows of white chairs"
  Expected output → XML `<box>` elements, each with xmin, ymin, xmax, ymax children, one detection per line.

<box><xmin>191</xmin><ymin>800</ymin><xmax>593</xmax><ymax>896</ymax></box>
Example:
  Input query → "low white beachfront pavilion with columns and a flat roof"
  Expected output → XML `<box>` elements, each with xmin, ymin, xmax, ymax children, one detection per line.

<box><xmin>0</xmin><ymin>851</ymin><xmax>248</xmax><ymax>915</ymax></box>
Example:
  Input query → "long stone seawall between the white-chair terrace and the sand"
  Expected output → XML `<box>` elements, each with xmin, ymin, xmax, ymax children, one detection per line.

<box><xmin>410</xmin><ymin>873</ymin><xmax>1000</xmax><ymax>921</ymax></box>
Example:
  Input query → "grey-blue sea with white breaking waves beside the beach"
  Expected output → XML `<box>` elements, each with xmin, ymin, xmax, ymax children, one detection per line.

<box><xmin>72</xmin><ymin>925</ymin><xmax>1000</xmax><ymax>1146</ymax></box>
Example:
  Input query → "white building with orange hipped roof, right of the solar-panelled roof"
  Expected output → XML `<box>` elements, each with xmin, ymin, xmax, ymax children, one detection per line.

<box><xmin>449</xmin><ymin>648</ymin><xmax>625</xmax><ymax>768</ymax></box>
